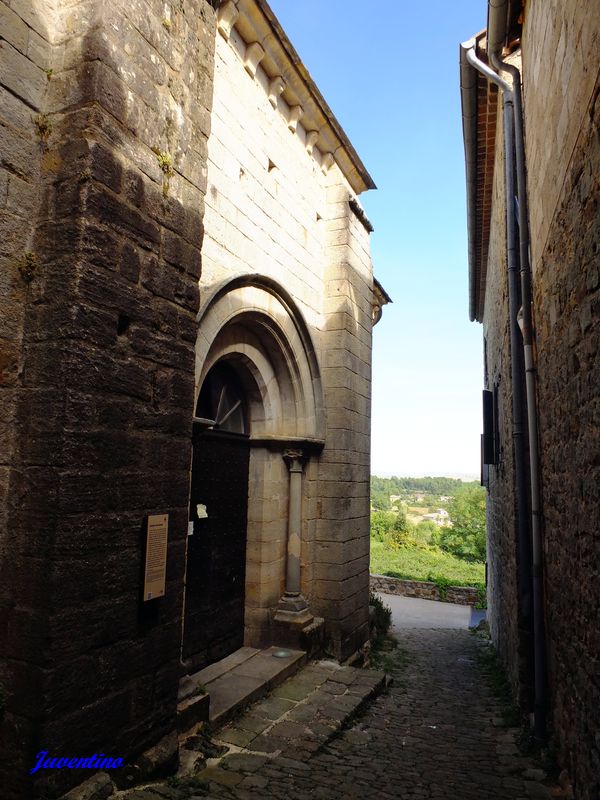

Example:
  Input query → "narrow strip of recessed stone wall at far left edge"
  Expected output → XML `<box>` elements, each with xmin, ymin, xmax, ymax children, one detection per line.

<box><xmin>0</xmin><ymin>0</ymin><xmax>54</xmax><ymax>798</ymax></box>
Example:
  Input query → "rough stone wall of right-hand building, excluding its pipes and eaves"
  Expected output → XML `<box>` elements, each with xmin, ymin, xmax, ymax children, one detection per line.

<box><xmin>484</xmin><ymin>0</ymin><xmax>600</xmax><ymax>800</ymax></box>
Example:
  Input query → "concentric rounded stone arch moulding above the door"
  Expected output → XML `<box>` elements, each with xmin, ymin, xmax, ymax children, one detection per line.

<box><xmin>196</xmin><ymin>274</ymin><xmax>325</xmax><ymax>449</ymax></box>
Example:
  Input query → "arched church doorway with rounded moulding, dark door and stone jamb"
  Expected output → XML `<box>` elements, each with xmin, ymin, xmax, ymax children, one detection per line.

<box><xmin>183</xmin><ymin>275</ymin><xmax>325</xmax><ymax>670</ymax></box>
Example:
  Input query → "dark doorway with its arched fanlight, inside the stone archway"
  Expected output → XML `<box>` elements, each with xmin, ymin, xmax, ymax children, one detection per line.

<box><xmin>183</xmin><ymin>360</ymin><xmax>250</xmax><ymax>669</ymax></box>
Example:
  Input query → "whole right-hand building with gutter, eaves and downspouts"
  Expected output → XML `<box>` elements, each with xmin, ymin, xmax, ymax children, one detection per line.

<box><xmin>461</xmin><ymin>0</ymin><xmax>600</xmax><ymax>800</ymax></box>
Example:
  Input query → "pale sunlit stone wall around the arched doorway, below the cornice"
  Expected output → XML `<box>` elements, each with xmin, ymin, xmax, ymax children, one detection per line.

<box><xmin>196</xmin><ymin>12</ymin><xmax>373</xmax><ymax>658</ymax></box>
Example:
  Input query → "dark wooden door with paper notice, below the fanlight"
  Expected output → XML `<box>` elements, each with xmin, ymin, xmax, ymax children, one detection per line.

<box><xmin>183</xmin><ymin>425</ymin><xmax>250</xmax><ymax>669</ymax></box>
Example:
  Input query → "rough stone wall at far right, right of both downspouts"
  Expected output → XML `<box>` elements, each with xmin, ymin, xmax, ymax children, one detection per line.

<box><xmin>523</xmin><ymin>0</ymin><xmax>600</xmax><ymax>800</ymax></box>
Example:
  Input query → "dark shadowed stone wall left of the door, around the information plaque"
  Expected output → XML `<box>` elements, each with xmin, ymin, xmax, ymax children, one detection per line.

<box><xmin>0</xmin><ymin>0</ymin><xmax>215</xmax><ymax>798</ymax></box>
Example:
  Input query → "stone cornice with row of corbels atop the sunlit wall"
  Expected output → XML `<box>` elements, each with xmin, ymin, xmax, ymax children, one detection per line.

<box><xmin>218</xmin><ymin>0</ymin><xmax>376</xmax><ymax>194</ymax></box>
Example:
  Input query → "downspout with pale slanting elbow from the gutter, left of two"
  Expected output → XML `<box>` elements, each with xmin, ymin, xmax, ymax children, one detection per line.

<box><xmin>461</xmin><ymin>40</ymin><xmax>531</xmax><ymax>700</ymax></box>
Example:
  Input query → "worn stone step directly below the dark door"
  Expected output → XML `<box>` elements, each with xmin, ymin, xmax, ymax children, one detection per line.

<box><xmin>177</xmin><ymin>647</ymin><xmax>306</xmax><ymax>732</ymax></box>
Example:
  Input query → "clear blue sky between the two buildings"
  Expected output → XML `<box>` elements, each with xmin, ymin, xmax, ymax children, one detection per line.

<box><xmin>269</xmin><ymin>0</ymin><xmax>487</xmax><ymax>476</ymax></box>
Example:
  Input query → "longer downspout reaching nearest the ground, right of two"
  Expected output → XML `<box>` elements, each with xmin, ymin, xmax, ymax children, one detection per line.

<box><xmin>488</xmin><ymin>0</ymin><xmax>547</xmax><ymax>742</ymax></box>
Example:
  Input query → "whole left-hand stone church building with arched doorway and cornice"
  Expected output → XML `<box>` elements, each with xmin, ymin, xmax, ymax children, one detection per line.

<box><xmin>0</xmin><ymin>0</ymin><xmax>389</xmax><ymax>800</ymax></box>
